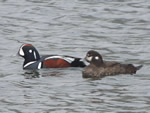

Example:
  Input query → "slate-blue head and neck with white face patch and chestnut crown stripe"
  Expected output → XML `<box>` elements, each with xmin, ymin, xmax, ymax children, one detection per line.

<box><xmin>18</xmin><ymin>44</ymin><xmax>40</xmax><ymax>65</ymax></box>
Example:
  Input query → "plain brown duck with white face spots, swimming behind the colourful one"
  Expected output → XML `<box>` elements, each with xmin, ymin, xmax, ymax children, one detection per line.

<box><xmin>82</xmin><ymin>50</ymin><xmax>142</xmax><ymax>78</ymax></box>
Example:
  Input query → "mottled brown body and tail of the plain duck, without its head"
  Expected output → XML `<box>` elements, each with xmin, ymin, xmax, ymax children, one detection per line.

<box><xmin>82</xmin><ymin>61</ymin><xmax>142</xmax><ymax>78</ymax></box>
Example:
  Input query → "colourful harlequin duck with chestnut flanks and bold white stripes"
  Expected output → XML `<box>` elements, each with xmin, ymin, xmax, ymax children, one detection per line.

<box><xmin>18</xmin><ymin>44</ymin><xmax>86</xmax><ymax>69</ymax></box>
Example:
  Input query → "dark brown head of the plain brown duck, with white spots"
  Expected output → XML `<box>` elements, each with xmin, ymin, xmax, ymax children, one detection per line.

<box><xmin>85</xmin><ymin>50</ymin><xmax>104</xmax><ymax>67</ymax></box>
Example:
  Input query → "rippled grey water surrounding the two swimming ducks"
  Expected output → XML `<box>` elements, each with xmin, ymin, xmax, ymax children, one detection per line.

<box><xmin>0</xmin><ymin>0</ymin><xmax>150</xmax><ymax>113</ymax></box>
